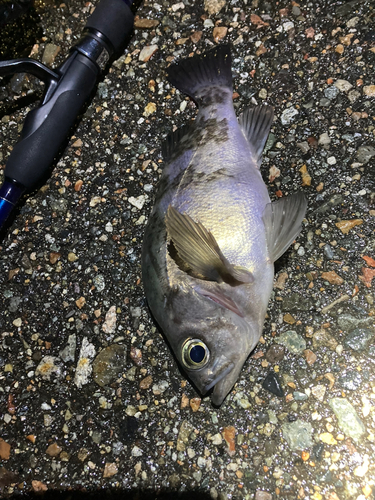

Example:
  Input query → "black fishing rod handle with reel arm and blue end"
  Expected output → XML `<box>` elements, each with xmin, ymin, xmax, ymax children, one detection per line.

<box><xmin>0</xmin><ymin>0</ymin><xmax>134</xmax><ymax>230</ymax></box>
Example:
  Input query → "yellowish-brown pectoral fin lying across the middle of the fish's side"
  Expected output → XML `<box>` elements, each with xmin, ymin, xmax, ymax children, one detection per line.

<box><xmin>166</xmin><ymin>205</ymin><xmax>254</xmax><ymax>283</ymax></box>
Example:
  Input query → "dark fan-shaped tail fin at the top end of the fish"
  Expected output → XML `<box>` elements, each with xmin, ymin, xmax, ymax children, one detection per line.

<box><xmin>167</xmin><ymin>44</ymin><xmax>232</xmax><ymax>104</ymax></box>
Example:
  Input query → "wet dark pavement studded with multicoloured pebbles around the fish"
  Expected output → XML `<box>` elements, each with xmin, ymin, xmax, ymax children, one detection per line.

<box><xmin>0</xmin><ymin>0</ymin><xmax>375</xmax><ymax>500</ymax></box>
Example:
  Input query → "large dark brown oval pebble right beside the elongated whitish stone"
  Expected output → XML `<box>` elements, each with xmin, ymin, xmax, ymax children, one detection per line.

<box><xmin>92</xmin><ymin>344</ymin><xmax>126</xmax><ymax>387</ymax></box>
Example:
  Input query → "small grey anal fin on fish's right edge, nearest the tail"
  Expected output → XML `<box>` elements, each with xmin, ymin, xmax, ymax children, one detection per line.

<box><xmin>238</xmin><ymin>104</ymin><xmax>274</xmax><ymax>166</ymax></box>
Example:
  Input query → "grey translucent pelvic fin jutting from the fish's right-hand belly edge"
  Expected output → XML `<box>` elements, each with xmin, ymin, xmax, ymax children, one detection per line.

<box><xmin>263</xmin><ymin>193</ymin><xmax>307</xmax><ymax>262</ymax></box>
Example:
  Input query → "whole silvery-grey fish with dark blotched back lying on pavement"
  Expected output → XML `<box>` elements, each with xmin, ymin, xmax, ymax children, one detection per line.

<box><xmin>142</xmin><ymin>44</ymin><xmax>307</xmax><ymax>407</ymax></box>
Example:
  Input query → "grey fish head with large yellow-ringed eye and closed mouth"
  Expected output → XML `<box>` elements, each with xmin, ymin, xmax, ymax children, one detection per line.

<box><xmin>164</xmin><ymin>285</ymin><xmax>261</xmax><ymax>406</ymax></box>
